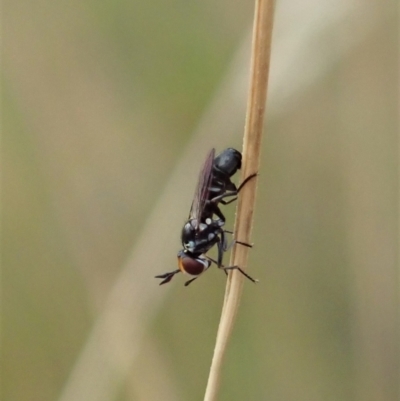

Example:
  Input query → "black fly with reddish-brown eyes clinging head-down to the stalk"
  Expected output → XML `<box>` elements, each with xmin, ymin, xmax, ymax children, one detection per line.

<box><xmin>156</xmin><ymin>148</ymin><xmax>256</xmax><ymax>285</ymax></box>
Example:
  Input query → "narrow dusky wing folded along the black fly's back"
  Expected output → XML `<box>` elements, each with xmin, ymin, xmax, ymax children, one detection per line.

<box><xmin>189</xmin><ymin>149</ymin><xmax>215</xmax><ymax>229</ymax></box>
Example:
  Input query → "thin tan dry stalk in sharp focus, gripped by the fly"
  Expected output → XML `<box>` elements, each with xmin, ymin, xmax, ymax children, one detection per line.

<box><xmin>204</xmin><ymin>0</ymin><xmax>274</xmax><ymax>401</ymax></box>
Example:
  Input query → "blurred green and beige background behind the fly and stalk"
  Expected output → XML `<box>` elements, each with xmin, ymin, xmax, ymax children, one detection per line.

<box><xmin>1</xmin><ymin>0</ymin><xmax>399</xmax><ymax>401</ymax></box>
